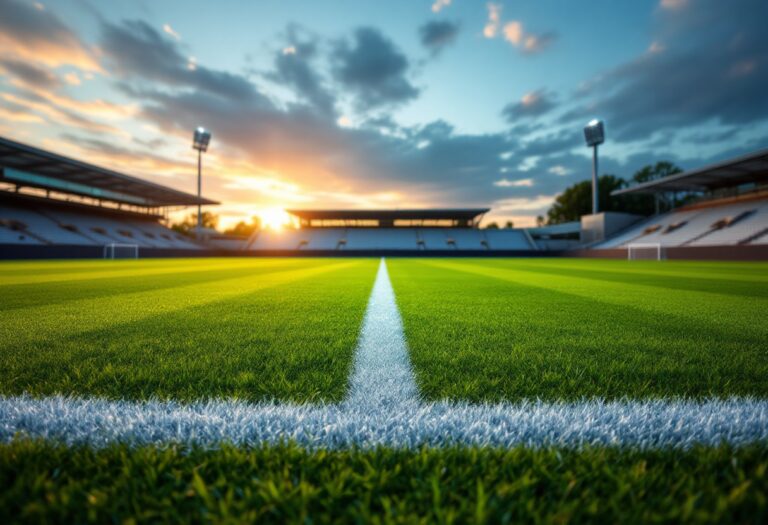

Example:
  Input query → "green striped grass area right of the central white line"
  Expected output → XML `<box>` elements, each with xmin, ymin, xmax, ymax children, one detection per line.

<box><xmin>389</xmin><ymin>259</ymin><xmax>768</xmax><ymax>401</ymax></box>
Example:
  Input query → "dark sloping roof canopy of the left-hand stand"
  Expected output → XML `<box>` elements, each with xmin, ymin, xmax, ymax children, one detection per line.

<box><xmin>0</xmin><ymin>137</ymin><xmax>219</xmax><ymax>208</ymax></box>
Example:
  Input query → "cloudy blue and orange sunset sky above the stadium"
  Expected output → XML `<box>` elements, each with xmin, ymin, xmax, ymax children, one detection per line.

<box><xmin>0</xmin><ymin>0</ymin><xmax>768</xmax><ymax>227</ymax></box>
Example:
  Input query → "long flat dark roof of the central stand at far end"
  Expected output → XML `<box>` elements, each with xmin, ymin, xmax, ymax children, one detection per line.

<box><xmin>286</xmin><ymin>208</ymin><xmax>490</xmax><ymax>227</ymax></box>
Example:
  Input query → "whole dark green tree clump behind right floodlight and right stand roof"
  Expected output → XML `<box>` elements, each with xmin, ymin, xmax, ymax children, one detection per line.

<box><xmin>547</xmin><ymin>161</ymin><xmax>682</xmax><ymax>224</ymax></box>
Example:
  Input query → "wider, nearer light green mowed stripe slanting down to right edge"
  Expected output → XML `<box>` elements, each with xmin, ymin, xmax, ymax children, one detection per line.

<box><xmin>423</xmin><ymin>259</ymin><xmax>768</xmax><ymax>336</ymax></box>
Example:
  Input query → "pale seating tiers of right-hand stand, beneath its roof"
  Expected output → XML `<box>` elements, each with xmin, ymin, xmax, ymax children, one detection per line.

<box><xmin>595</xmin><ymin>200</ymin><xmax>768</xmax><ymax>248</ymax></box>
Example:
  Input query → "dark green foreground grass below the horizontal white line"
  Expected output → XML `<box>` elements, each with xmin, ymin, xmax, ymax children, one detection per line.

<box><xmin>0</xmin><ymin>441</ymin><xmax>768</xmax><ymax>523</ymax></box>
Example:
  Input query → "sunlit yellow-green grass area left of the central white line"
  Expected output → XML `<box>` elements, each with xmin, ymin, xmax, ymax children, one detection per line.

<box><xmin>0</xmin><ymin>259</ymin><xmax>377</xmax><ymax>401</ymax></box>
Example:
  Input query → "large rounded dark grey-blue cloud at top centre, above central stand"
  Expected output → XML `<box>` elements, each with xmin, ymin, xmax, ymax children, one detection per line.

<box><xmin>331</xmin><ymin>27</ymin><xmax>419</xmax><ymax>111</ymax></box>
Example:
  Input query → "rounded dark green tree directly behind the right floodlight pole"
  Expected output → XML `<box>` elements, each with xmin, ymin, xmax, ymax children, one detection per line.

<box><xmin>547</xmin><ymin>175</ymin><xmax>627</xmax><ymax>224</ymax></box>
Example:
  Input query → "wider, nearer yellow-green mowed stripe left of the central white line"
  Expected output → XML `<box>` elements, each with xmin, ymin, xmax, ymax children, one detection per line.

<box><xmin>0</xmin><ymin>260</ymin><xmax>358</xmax><ymax>347</ymax></box>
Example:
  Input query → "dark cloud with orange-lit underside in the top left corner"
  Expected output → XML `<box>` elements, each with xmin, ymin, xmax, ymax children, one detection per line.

<box><xmin>0</xmin><ymin>0</ymin><xmax>101</xmax><ymax>71</ymax></box>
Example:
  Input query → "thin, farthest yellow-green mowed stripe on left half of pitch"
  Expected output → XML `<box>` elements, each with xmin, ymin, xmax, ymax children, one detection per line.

<box><xmin>0</xmin><ymin>258</ymin><xmax>307</xmax><ymax>284</ymax></box>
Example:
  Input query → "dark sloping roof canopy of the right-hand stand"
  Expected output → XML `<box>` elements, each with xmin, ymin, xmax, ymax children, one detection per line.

<box><xmin>611</xmin><ymin>145</ymin><xmax>768</xmax><ymax>195</ymax></box>
